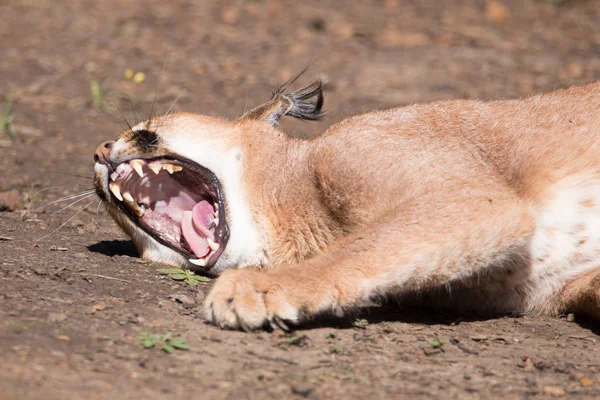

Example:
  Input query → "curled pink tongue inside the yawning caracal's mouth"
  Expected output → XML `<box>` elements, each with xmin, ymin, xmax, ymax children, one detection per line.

<box><xmin>181</xmin><ymin>200</ymin><xmax>215</xmax><ymax>258</ymax></box>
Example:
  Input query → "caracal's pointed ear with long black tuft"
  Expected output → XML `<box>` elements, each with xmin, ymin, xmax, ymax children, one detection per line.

<box><xmin>241</xmin><ymin>79</ymin><xmax>326</xmax><ymax>127</ymax></box>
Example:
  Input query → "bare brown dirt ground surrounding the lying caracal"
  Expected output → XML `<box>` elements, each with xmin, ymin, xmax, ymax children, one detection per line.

<box><xmin>0</xmin><ymin>0</ymin><xmax>600</xmax><ymax>399</ymax></box>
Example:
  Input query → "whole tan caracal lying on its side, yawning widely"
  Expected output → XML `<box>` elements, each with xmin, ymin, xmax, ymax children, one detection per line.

<box><xmin>94</xmin><ymin>77</ymin><xmax>600</xmax><ymax>329</ymax></box>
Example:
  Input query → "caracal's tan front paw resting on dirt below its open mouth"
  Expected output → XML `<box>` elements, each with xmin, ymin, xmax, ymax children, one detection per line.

<box><xmin>204</xmin><ymin>270</ymin><xmax>302</xmax><ymax>331</ymax></box>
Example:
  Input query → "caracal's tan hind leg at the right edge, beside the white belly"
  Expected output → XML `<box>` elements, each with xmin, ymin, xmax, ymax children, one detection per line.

<box><xmin>558</xmin><ymin>267</ymin><xmax>600</xmax><ymax>321</ymax></box>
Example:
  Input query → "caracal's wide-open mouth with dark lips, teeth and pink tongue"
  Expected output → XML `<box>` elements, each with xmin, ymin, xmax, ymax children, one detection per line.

<box><xmin>102</xmin><ymin>157</ymin><xmax>229</xmax><ymax>269</ymax></box>
